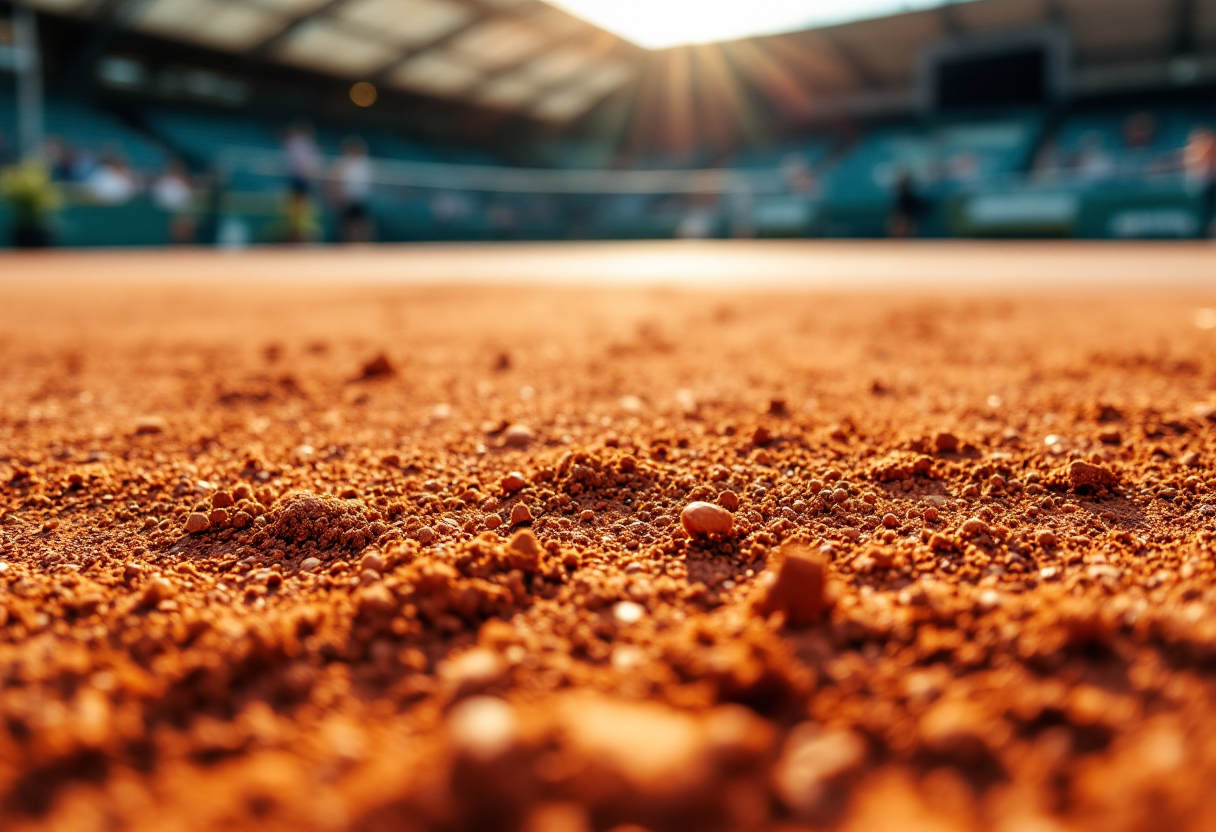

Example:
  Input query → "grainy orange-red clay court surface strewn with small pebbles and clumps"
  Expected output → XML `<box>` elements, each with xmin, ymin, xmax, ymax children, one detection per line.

<box><xmin>0</xmin><ymin>243</ymin><xmax>1216</xmax><ymax>832</ymax></box>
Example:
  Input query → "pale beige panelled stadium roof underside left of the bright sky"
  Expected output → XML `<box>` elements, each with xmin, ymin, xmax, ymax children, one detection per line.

<box><xmin>22</xmin><ymin>0</ymin><xmax>638</xmax><ymax>122</ymax></box>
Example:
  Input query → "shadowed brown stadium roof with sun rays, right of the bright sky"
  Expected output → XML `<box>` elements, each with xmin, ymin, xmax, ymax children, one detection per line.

<box><xmin>621</xmin><ymin>0</ymin><xmax>1216</xmax><ymax>130</ymax></box>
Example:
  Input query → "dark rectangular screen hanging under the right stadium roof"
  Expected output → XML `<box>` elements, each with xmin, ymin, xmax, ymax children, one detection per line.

<box><xmin>935</xmin><ymin>46</ymin><xmax>1047</xmax><ymax>111</ymax></box>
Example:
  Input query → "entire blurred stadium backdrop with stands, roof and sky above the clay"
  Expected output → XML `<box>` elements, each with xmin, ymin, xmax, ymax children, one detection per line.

<box><xmin>0</xmin><ymin>0</ymin><xmax>1216</xmax><ymax>247</ymax></box>
